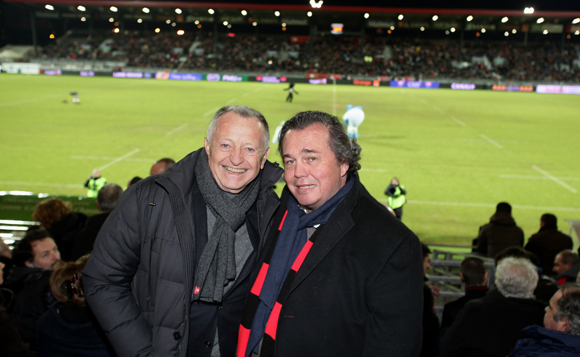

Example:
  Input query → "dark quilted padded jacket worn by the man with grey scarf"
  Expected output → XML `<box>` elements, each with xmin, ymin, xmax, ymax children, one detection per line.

<box><xmin>83</xmin><ymin>148</ymin><xmax>282</xmax><ymax>357</ymax></box>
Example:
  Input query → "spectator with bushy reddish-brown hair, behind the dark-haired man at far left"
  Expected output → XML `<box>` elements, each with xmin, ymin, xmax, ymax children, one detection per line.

<box><xmin>32</xmin><ymin>197</ymin><xmax>87</xmax><ymax>261</ymax></box>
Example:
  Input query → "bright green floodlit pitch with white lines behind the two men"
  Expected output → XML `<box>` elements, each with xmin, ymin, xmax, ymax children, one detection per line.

<box><xmin>0</xmin><ymin>74</ymin><xmax>580</xmax><ymax>245</ymax></box>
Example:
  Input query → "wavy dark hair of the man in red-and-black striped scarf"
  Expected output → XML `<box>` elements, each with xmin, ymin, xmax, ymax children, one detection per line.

<box><xmin>278</xmin><ymin>111</ymin><xmax>362</xmax><ymax>173</ymax></box>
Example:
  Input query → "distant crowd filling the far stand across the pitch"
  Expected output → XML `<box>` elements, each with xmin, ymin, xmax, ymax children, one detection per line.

<box><xmin>41</xmin><ymin>33</ymin><xmax>580</xmax><ymax>82</ymax></box>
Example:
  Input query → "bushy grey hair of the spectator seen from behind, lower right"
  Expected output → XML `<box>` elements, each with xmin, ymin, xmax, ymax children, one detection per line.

<box><xmin>495</xmin><ymin>257</ymin><xmax>539</xmax><ymax>299</ymax></box>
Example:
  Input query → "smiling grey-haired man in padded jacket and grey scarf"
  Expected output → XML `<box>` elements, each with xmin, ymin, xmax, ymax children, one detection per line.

<box><xmin>83</xmin><ymin>106</ymin><xmax>282</xmax><ymax>357</ymax></box>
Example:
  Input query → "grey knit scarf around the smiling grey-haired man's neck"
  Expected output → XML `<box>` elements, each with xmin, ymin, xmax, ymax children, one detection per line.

<box><xmin>192</xmin><ymin>150</ymin><xmax>261</xmax><ymax>302</ymax></box>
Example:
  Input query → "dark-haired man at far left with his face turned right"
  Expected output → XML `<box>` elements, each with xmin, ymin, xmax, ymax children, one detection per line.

<box><xmin>6</xmin><ymin>228</ymin><xmax>60</xmax><ymax>350</ymax></box>
